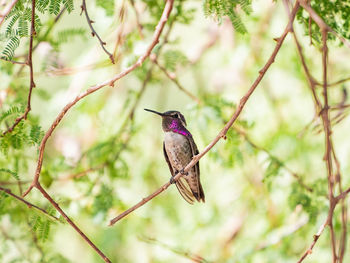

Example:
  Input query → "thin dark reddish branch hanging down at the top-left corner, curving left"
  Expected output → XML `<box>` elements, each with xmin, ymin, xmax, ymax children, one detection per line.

<box><xmin>2</xmin><ymin>0</ymin><xmax>36</xmax><ymax>136</ymax></box>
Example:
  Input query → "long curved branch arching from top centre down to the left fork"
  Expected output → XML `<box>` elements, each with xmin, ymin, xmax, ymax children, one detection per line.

<box><xmin>23</xmin><ymin>0</ymin><xmax>174</xmax><ymax>196</ymax></box>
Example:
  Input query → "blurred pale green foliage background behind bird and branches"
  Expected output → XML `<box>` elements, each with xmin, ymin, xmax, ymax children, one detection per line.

<box><xmin>0</xmin><ymin>0</ymin><xmax>350</xmax><ymax>263</ymax></box>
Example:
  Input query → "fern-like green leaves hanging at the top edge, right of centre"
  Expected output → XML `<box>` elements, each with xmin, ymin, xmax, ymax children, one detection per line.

<box><xmin>203</xmin><ymin>0</ymin><xmax>252</xmax><ymax>34</ymax></box>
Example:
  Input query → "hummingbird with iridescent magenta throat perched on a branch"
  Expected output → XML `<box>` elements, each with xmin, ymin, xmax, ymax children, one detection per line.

<box><xmin>145</xmin><ymin>109</ymin><xmax>205</xmax><ymax>204</ymax></box>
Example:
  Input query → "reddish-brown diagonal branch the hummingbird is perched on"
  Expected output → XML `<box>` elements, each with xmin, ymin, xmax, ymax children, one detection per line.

<box><xmin>109</xmin><ymin>2</ymin><xmax>299</xmax><ymax>226</ymax></box>
